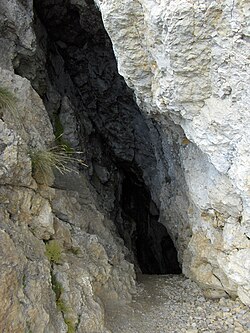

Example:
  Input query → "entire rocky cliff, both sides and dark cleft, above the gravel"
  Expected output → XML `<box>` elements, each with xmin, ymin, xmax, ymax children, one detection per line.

<box><xmin>0</xmin><ymin>0</ymin><xmax>250</xmax><ymax>333</ymax></box>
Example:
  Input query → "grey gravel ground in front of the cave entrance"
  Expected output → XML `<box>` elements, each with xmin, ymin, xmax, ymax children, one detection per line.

<box><xmin>107</xmin><ymin>275</ymin><xmax>250</xmax><ymax>333</ymax></box>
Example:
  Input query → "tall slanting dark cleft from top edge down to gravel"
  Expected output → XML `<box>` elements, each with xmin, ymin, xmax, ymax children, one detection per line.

<box><xmin>16</xmin><ymin>0</ymin><xmax>181</xmax><ymax>274</ymax></box>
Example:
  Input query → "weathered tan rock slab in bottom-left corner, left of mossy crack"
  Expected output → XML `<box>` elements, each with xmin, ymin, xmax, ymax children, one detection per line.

<box><xmin>0</xmin><ymin>209</ymin><xmax>66</xmax><ymax>332</ymax></box>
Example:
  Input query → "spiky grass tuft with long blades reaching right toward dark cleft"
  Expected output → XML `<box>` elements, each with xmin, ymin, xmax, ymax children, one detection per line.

<box><xmin>29</xmin><ymin>145</ymin><xmax>87</xmax><ymax>184</ymax></box>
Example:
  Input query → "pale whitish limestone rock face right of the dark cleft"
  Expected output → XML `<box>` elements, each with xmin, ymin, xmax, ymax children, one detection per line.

<box><xmin>95</xmin><ymin>0</ymin><xmax>250</xmax><ymax>304</ymax></box>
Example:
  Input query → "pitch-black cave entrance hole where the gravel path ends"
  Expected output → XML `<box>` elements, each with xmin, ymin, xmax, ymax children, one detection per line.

<box><xmin>119</xmin><ymin>171</ymin><xmax>181</xmax><ymax>274</ymax></box>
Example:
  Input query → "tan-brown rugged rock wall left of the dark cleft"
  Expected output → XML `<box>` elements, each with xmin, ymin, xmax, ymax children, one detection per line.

<box><xmin>0</xmin><ymin>0</ymin><xmax>135</xmax><ymax>333</ymax></box>
